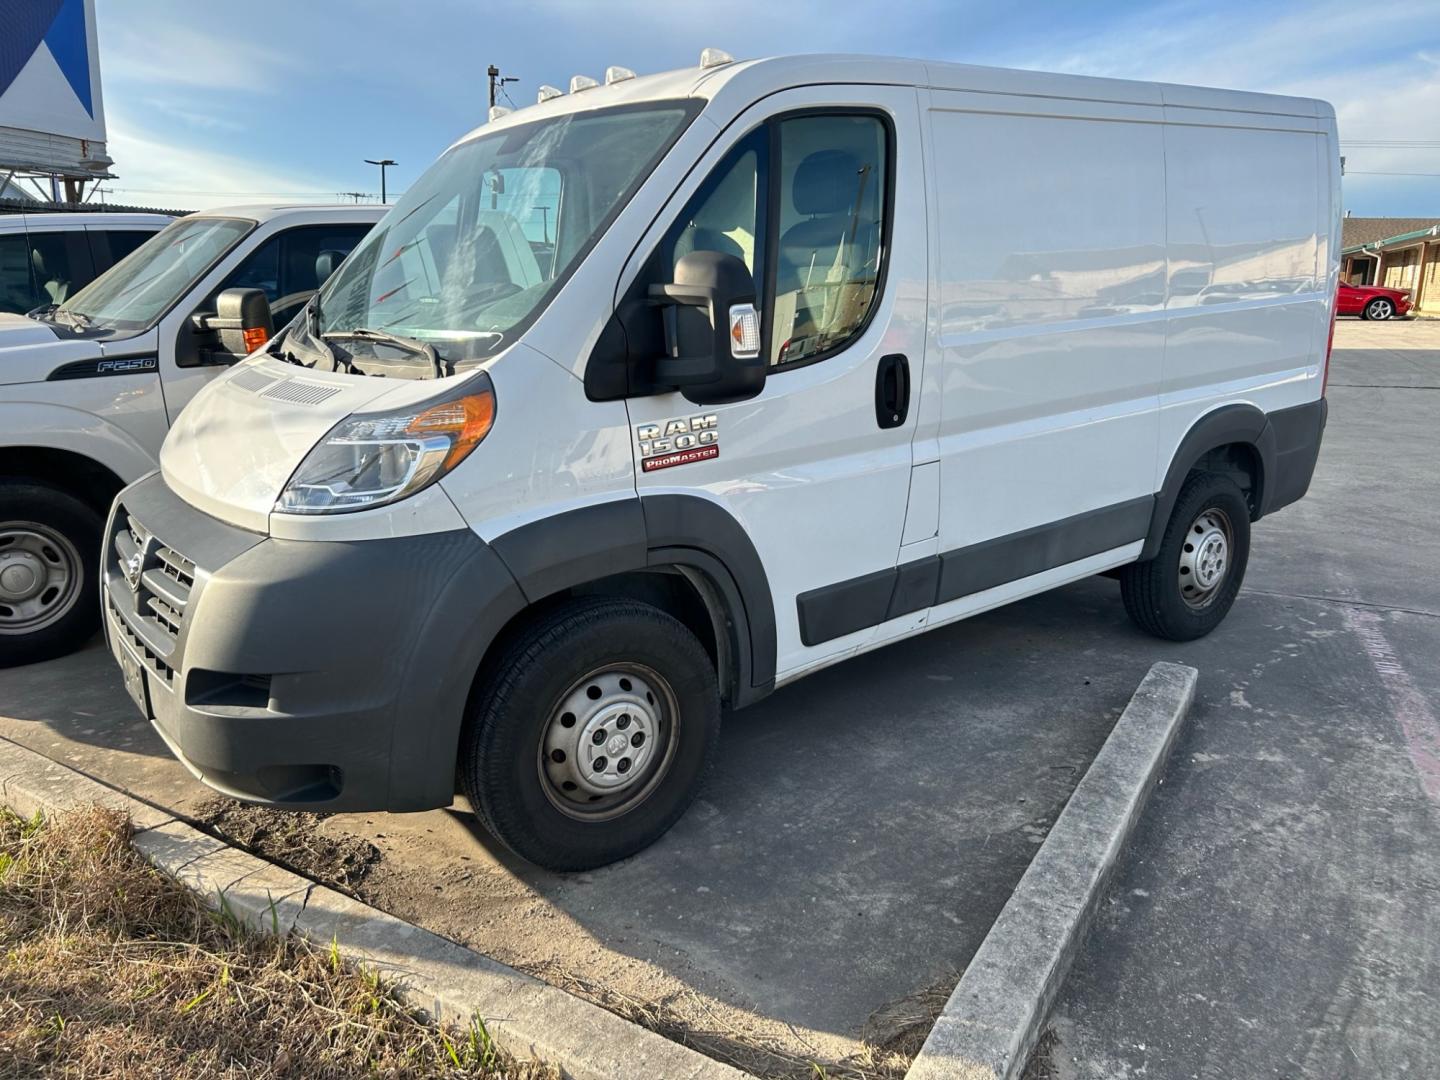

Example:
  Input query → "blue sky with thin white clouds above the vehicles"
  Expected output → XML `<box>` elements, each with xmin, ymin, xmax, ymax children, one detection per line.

<box><xmin>96</xmin><ymin>0</ymin><xmax>1440</xmax><ymax>216</ymax></box>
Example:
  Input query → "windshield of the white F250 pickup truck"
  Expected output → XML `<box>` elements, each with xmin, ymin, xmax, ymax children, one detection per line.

<box><xmin>52</xmin><ymin>217</ymin><xmax>255</xmax><ymax>330</ymax></box>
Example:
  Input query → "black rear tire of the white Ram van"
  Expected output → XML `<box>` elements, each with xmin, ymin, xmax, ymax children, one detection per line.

<box><xmin>1120</xmin><ymin>472</ymin><xmax>1250</xmax><ymax>641</ymax></box>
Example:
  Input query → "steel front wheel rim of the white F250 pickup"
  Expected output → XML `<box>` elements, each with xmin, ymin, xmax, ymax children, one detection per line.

<box><xmin>0</xmin><ymin>521</ymin><xmax>84</xmax><ymax>634</ymax></box>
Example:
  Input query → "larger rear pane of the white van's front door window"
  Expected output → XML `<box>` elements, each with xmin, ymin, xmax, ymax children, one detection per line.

<box><xmin>769</xmin><ymin>114</ymin><xmax>887</xmax><ymax>364</ymax></box>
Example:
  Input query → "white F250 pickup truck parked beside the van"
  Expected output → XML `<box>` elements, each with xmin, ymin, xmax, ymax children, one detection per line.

<box><xmin>0</xmin><ymin>198</ymin><xmax>384</xmax><ymax>667</ymax></box>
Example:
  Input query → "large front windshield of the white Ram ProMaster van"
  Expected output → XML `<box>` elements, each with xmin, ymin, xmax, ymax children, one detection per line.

<box><xmin>312</xmin><ymin>102</ymin><xmax>694</xmax><ymax>370</ymax></box>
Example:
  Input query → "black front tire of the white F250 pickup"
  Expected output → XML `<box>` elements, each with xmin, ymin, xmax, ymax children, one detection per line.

<box><xmin>0</xmin><ymin>480</ymin><xmax>104</xmax><ymax>668</ymax></box>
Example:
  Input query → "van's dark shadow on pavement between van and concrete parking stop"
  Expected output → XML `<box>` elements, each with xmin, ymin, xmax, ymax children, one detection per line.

<box><xmin>437</xmin><ymin>579</ymin><xmax>1159</xmax><ymax>1038</ymax></box>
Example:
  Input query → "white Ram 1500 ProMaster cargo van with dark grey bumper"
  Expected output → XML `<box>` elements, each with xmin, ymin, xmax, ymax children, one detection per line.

<box><xmin>104</xmin><ymin>53</ymin><xmax>1339</xmax><ymax>868</ymax></box>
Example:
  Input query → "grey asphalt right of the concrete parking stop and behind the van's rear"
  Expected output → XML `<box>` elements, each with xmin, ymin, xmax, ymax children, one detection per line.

<box><xmin>1053</xmin><ymin>323</ymin><xmax>1440</xmax><ymax>1080</ymax></box>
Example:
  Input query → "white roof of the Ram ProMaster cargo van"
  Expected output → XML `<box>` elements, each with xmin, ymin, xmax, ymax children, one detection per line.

<box><xmin>458</xmin><ymin>53</ymin><xmax>1335</xmax><ymax>151</ymax></box>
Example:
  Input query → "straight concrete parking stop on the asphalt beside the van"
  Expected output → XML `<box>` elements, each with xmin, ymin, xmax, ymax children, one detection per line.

<box><xmin>906</xmin><ymin>664</ymin><xmax>1197</xmax><ymax>1080</ymax></box>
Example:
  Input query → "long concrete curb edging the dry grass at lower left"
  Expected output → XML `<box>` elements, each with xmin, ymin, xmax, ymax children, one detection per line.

<box><xmin>0</xmin><ymin>739</ymin><xmax>746</xmax><ymax>1080</ymax></box>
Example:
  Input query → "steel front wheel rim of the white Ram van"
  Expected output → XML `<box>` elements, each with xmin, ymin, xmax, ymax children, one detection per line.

<box><xmin>537</xmin><ymin>664</ymin><xmax>680</xmax><ymax>821</ymax></box>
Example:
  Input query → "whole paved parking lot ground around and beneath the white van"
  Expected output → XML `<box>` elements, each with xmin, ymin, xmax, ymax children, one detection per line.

<box><xmin>0</xmin><ymin>323</ymin><xmax>1440</xmax><ymax>1077</ymax></box>
